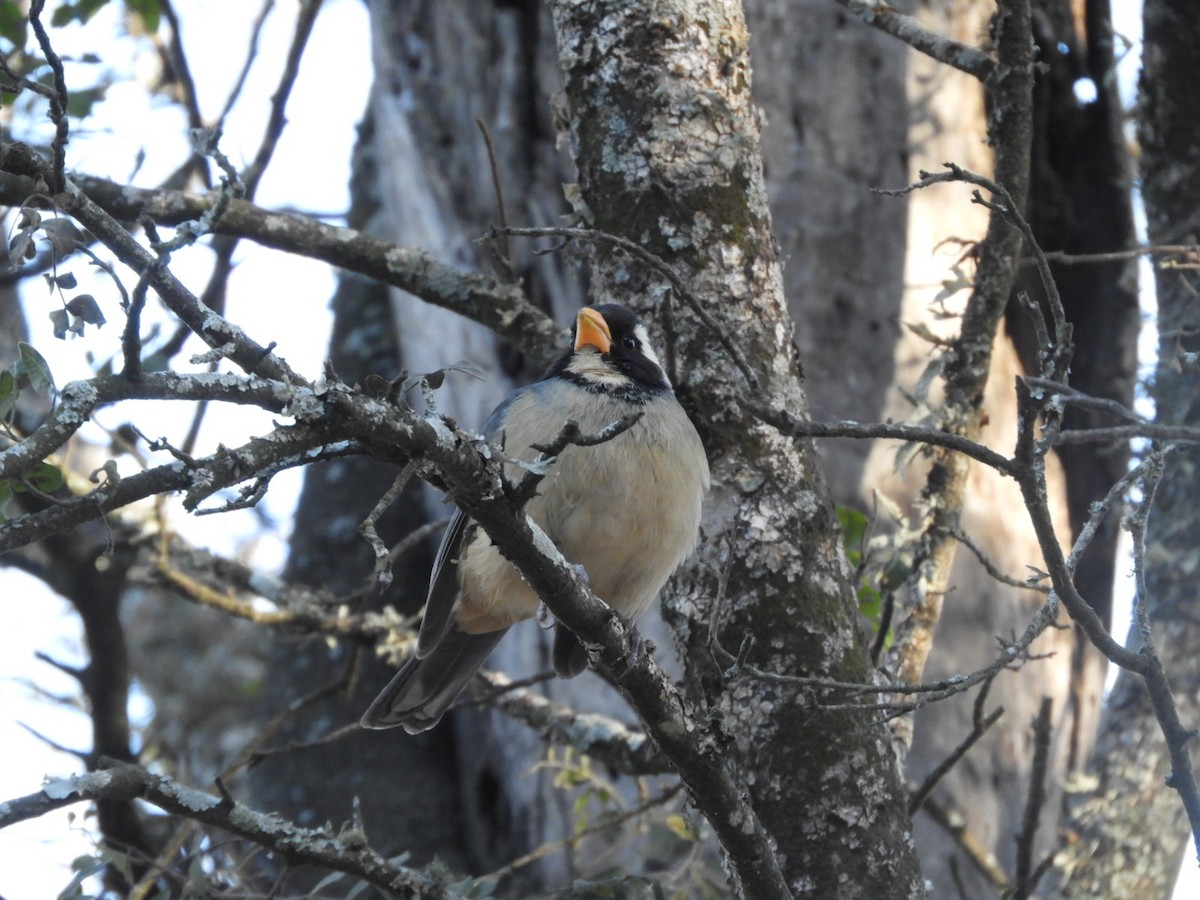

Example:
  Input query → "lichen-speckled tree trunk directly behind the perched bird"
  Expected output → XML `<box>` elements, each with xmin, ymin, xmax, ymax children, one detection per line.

<box><xmin>553</xmin><ymin>2</ymin><xmax>922</xmax><ymax>898</ymax></box>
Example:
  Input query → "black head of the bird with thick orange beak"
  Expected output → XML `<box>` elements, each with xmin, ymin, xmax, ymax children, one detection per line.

<box><xmin>546</xmin><ymin>304</ymin><xmax>671</xmax><ymax>400</ymax></box>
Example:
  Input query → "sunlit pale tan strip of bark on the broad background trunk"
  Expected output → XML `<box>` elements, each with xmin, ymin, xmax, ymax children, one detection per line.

<box><xmin>866</xmin><ymin>2</ymin><xmax>1069</xmax><ymax>896</ymax></box>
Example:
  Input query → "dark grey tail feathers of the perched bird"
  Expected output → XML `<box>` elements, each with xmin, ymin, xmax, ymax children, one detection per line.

<box><xmin>362</xmin><ymin>628</ymin><xmax>508</xmax><ymax>734</ymax></box>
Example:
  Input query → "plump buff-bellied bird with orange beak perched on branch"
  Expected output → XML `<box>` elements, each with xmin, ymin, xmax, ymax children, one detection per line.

<box><xmin>361</xmin><ymin>304</ymin><xmax>709</xmax><ymax>734</ymax></box>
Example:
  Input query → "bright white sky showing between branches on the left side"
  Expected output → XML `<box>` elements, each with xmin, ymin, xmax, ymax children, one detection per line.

<box><xmin>0</xmin><ymin>0</ymin><xmax>371</xmax><ymax>900</ymax></box>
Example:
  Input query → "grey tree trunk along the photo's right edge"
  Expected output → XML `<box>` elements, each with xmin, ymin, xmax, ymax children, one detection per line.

<box><xmin>1046</xmin><ymin>0</ymin><xmax>1200</xmax><ymax>898</ymax></box>
